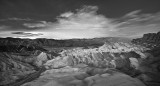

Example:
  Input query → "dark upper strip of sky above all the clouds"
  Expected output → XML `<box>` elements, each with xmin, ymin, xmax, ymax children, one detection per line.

<box><xmin>0</xmin><ymin>0</ymin><xmax>160</xmax><ymax>21</ymax></box>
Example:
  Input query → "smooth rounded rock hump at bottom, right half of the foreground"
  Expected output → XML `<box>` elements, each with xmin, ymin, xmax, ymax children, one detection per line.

<box><xmin>85</xmin><ymin>73</ymin><xmax>145</xmax><ymax>86</ymax></box>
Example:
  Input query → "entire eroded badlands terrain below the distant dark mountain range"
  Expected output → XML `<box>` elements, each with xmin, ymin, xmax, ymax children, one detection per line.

<box><xmin>0</xmin><ymin>35</ymin><xmax>160</xmax><ymax>86</ymax></box>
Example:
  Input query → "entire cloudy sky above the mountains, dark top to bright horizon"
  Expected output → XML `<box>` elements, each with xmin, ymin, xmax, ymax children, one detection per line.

<box><xmin>0</xmin><ymin>0</ymin><xmax>160</xmax><ymax>39</ymax></box>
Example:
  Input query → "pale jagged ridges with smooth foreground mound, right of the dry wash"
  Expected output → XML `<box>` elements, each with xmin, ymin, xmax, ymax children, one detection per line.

<box><xmin>22</xmin><ymin>42</ymin><xmax>160</xmax><ymax>86</ymax></box>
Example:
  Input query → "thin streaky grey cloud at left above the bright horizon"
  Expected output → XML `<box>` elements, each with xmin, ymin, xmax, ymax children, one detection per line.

<box><xmin>0</xmin><ymin>17</ymin><xmax>46</xmax><ymax>31</ymax></box>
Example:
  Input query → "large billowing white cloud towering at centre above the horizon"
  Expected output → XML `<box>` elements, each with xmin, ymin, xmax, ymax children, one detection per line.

<box><xmin>34</xmin><ymin>6</ymin><xmax>116</xmax><ymax>39</ymax></box>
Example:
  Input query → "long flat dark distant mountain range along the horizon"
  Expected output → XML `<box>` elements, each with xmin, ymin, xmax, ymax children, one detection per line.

<box><xmin>0</xmin><ymin>37</ymin><xmax>130</xmax><ymax>51</ymax></box>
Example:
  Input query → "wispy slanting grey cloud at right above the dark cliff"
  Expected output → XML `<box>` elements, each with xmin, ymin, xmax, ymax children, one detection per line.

<box><xmin>115</xmin><ymin>10</ymin><xmax>160</xmax><ymax>37</ymax></box>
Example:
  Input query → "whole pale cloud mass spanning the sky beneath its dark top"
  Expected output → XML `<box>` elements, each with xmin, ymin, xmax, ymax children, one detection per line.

<box><xmin>0</xmin><ymin>6</ymin><xmax>160</xmax><ymax>39</ymax></box>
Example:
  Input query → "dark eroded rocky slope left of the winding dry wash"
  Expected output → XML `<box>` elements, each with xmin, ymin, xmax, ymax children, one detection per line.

<box><xmin>0</xmin><ymin>50</ymin><xmax>54</xmax><ymax>86</ymax></box>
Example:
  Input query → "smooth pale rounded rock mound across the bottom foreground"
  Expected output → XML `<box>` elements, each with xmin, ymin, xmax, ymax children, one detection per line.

<box><xmin>22</xmin><ymin>67</ymin><xmax>145</xmax><ymax>86</ymax></box>
